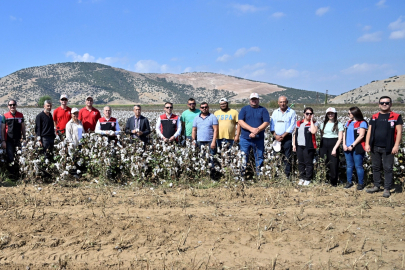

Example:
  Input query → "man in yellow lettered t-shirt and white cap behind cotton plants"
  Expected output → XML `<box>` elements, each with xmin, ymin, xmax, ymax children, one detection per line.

<box><xmin>214</xmin><ymin>98</ymin><xmax>240</xmax><ymax>149</ymax></box>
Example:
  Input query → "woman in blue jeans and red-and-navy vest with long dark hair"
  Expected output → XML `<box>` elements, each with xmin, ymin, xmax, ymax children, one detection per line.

<box><xmin>343</xmin><ymin>107</ymin><xmax>368</xmax><ymax>190</ymax></box>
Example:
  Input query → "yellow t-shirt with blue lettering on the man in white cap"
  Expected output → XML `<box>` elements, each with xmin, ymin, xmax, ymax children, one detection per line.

<box><xmin>214</xmin><ymin>109</ymin><xmax>238</xmax><ymax>140</ymax></box>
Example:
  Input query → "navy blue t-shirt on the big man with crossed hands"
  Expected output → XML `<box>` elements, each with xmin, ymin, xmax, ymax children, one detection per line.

<box><xmin>239</xmin><ymin>105</ymin><xmax>270</xmax><ymax>140</ymax></box>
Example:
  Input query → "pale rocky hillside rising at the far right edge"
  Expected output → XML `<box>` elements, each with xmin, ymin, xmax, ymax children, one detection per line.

<box><xmin>330</xmin><ymin>75</ymin><xmax>405</xmax><ymax>104</ymax></box>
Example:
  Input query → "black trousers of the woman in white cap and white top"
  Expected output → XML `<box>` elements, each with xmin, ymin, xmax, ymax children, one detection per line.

<box><xmin>319</xmin><ymin>138</ymin><xmax>339</xmax><ymax>185</ymax></box>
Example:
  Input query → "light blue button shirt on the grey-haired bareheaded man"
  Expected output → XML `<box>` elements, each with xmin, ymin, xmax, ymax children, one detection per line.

<box><xmin>270</xmin><ymin>107</ymin><xmax>296</xmax><ymax>135</ymax></box>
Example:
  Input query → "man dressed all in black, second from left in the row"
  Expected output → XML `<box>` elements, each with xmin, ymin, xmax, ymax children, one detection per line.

<box><xmin>35</xmin><ymin>100</ymin><xmax>55</xmax><ymax>158</ymax></box>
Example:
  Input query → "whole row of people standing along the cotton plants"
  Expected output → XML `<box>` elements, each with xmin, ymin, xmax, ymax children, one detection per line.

<box><xmin>1</xmin><ymin>93</ymin><xmax>403</xmax><ymax>197</ymax></box>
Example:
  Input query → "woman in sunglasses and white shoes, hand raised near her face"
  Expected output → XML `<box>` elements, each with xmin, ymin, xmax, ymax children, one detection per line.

<box><xmin>293</xmin><ymin>107</ymin><xmax>318</xmax><ymax>186</ymax></box>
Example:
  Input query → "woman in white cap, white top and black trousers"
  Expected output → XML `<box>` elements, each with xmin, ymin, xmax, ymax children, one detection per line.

<box><xmin>319</xmin><ymin>107</ymin><xmax>344</xmax><ymax>187</ymax></box>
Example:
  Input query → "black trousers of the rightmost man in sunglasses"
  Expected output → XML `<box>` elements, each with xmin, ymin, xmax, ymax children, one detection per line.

<box><xmin>371</xmin><ymin>146</ymin><xmax>394</xmax><ymax>189</ymax></box>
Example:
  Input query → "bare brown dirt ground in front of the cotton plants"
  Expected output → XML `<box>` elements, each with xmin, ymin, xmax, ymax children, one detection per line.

<box><xmin>0</xmin><ymin>181</ymin><xmax>405</xmax><ymax>270</ymax></box>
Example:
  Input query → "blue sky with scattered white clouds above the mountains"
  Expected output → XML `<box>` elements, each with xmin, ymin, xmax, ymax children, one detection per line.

<box><xmin>0</xmin><ymin>0</ymin><xmax>405</xmax><ymax>94</ymax></box>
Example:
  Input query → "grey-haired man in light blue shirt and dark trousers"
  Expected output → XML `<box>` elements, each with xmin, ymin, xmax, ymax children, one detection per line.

<box><xmin>270</xmin><ymin>96</ymin><xmax>296</xmax><ymax>177</ymax></box>
